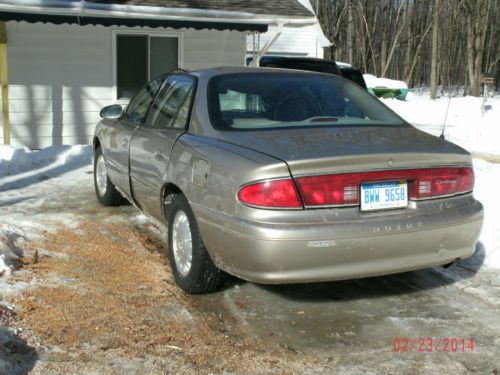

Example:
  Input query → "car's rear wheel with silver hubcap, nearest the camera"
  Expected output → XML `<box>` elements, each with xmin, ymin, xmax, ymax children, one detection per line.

<box><xmin>168</xmin><ymin>194</ymin><xmax>223</xmax><ymax>294</ymax></box>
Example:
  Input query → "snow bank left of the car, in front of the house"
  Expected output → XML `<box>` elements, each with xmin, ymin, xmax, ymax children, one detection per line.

<box><xmin>0</xmin><ymin>145</ymin><xmax>92</xmax><ymax>280</ymax></box>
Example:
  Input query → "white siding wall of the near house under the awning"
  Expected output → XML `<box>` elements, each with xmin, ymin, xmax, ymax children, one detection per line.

<box><xmin>0</xmin><ymin>22</ymin><xmax>246</xmax><ymax>148</ymax></box>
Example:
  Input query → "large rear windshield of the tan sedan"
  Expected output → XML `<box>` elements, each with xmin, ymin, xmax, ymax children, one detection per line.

<box><xmin>208</xmin><ymin>73</ymin><xmax>404</xmax><ymax>130</ymax></box>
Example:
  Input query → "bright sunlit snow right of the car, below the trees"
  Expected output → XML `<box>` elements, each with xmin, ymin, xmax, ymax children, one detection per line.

<box><xmin>381</xmin><ymin>91</ymin><xmax>500</xmax><ymax>161</ymax></box>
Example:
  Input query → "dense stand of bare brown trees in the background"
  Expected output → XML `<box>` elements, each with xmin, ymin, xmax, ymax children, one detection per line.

<box><xmin>318</xmin><ymin>0</ymin><xmax>500</xmax><ymax>96</ymax></box>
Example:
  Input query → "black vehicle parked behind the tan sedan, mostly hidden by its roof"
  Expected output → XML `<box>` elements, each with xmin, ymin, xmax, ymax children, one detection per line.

<box><xmin>247</xmin><ymin>56</ymin><xmax>367</xmax><ymax>90</ymax></box>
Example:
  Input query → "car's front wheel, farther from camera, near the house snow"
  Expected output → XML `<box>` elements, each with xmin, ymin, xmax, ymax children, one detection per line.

<box><xmin>94</xmin><ymin>147</ymin><xmax>124</xmax><ymax>206</ymax></box>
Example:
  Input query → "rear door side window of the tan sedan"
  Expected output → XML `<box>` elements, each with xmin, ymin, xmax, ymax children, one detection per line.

<box><xmin>146</xmin><ymin>75</ymin><xmax>194</xmax><ymax>129</ymax></box>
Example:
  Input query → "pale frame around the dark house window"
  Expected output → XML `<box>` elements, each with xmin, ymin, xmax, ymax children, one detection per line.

<box><xmin>111</xmin><ymin>29</ymin><xmax>184</xmax><ymax>105</ymax></box>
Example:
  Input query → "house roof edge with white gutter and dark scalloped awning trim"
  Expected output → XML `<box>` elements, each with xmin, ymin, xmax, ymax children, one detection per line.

<box><xmin>0</xmin><ymin>0</ymin><xmax>317</xmax><ymax>32</ymax></box>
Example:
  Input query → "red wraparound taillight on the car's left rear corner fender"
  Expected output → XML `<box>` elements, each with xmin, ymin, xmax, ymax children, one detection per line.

<box><xmin>238</xmin><ymin>179</ymin><xmax>302</xmax><ymax>208</ymax></box>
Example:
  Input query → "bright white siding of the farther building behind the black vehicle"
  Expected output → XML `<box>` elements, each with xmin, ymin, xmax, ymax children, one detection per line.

<box><xmin>247</xmin><ymin>26</ymin><xmax>323</xmax><ymax>58</ymax></box>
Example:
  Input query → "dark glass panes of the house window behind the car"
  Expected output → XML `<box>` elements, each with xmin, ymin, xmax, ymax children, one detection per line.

<box><xmin>116</xmin><ymin>34</ymin><xmax>179</xmax><ymax>99</ymax></box>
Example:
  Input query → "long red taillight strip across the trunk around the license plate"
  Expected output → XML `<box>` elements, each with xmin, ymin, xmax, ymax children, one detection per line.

<box><xmin>296</xmin><ymin>168</ymin><xmax>474</xmax><ymax>206</ymax></box>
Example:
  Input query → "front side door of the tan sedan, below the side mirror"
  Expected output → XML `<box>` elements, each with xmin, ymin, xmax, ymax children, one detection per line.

<box><xmin>104</xmin><ymin>76</ymin><xmax>165</xmax><ymax>197</ymax></box>
